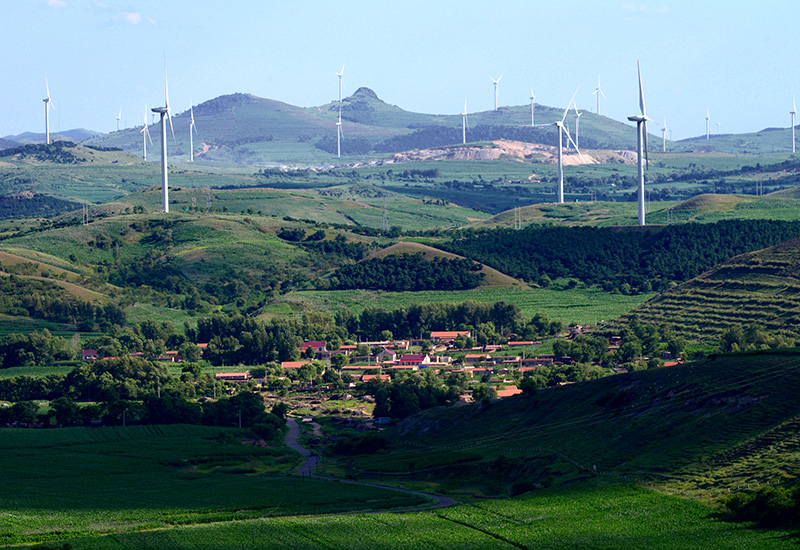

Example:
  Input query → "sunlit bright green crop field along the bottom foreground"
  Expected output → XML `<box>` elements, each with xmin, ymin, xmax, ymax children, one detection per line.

<box><xmin>34</xmin><ymin>483</ymin><xmax>796</xmax><ymax>550</ymax></box>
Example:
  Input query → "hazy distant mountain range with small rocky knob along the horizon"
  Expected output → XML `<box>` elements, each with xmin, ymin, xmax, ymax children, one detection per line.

<box><xmin>7</xmin><ymin>88</ymin><xmax>791</xmax><ymax>166</ymax></box>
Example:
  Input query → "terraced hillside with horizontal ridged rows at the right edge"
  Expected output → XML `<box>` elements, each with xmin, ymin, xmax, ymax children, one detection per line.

<box><xmin>622</xmin><ymin>239</ymin><xmax>800</xmax><ymax>341</ymax></box>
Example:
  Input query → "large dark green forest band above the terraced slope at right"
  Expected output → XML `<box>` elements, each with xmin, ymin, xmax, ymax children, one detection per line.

<box><xmin>442</xmin><ymin>220</ymin><xmax>800</xmax><ymax>293</ymax></box>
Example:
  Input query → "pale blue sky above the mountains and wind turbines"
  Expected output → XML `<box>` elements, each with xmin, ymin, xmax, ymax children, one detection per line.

<box><xmin>0</xmin><ymin>0</ymin><xmax>800</xmax><ymax>140</ymax></box>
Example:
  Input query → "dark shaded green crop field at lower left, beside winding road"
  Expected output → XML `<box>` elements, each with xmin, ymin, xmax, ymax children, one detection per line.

<box><xmin>0</xmin><ymin>425</ymin><xmax>427</xmax><ymax>545</ymax></box>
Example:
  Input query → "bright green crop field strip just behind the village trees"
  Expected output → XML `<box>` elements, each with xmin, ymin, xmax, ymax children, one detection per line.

<box><xmin>264</xmin><ymin>288</ymin><xmax>654</xmax><ymax>325</ymax></box>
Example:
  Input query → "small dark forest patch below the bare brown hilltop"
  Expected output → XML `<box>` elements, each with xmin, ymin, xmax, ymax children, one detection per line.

<box><xmin>328</xmin><ymin>254</ymin><xmax>483</xmax><ymax>292</ymax></box>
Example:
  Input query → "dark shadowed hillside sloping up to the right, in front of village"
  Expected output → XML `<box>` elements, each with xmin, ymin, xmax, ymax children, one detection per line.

<box><xmin>329</xmin><ymin>353</ymin><xmax>800</xmax><ymax>498</ymax></box>
